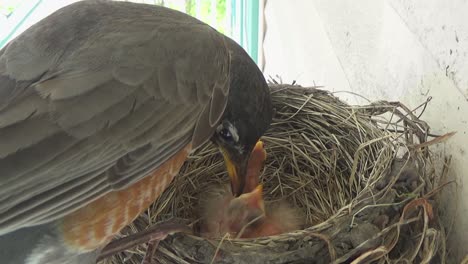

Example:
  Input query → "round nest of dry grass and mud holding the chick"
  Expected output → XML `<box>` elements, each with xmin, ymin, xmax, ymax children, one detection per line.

<box><xmin>101</xmin><ymin>84</ymin><xmax>450</xmax><ymax>263</ymax></box>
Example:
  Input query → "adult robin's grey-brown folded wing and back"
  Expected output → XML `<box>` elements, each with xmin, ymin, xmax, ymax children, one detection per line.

<box><xmin>0</xmin><ymin>1</ymin><xmax>229</xmax><ymax>234</ymax></box>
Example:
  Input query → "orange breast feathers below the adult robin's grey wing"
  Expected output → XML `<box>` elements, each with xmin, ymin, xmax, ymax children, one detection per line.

<box><xmin>61</xmin><ymin>145</ymin><xmax>191</xmax><ymax>250</ymax></box>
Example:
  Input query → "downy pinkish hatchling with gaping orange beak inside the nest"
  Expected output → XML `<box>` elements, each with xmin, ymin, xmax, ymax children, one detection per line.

<box><xmin>201</xmin><ymin>142</ymin><xmax>301</xmax><ymax>238</ymax></box>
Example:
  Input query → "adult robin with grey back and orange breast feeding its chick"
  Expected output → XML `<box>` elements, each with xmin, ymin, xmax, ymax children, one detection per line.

<box><xmin>0</xmin><ymin>1</ymin><xmax>272</xmax><ymax>264</ymax></box>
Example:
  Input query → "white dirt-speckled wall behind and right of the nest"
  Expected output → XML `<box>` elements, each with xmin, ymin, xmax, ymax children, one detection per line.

<box><xmin>264</xmin><ymin>0</ymin><xmax>468</xmax><ymax>257</ymax></box>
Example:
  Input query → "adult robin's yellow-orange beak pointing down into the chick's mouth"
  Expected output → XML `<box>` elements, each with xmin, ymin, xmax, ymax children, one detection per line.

<box><xmin>221</xmin><ymin>150</ymin><xmax>249</xmax><ymax>197</ymax></box>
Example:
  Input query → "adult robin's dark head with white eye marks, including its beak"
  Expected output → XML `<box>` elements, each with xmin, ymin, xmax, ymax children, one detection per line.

<box><xmin>213</xmin><ymin>38</ymin><xmax>273</xmax><ymax>196</ymax></box>
